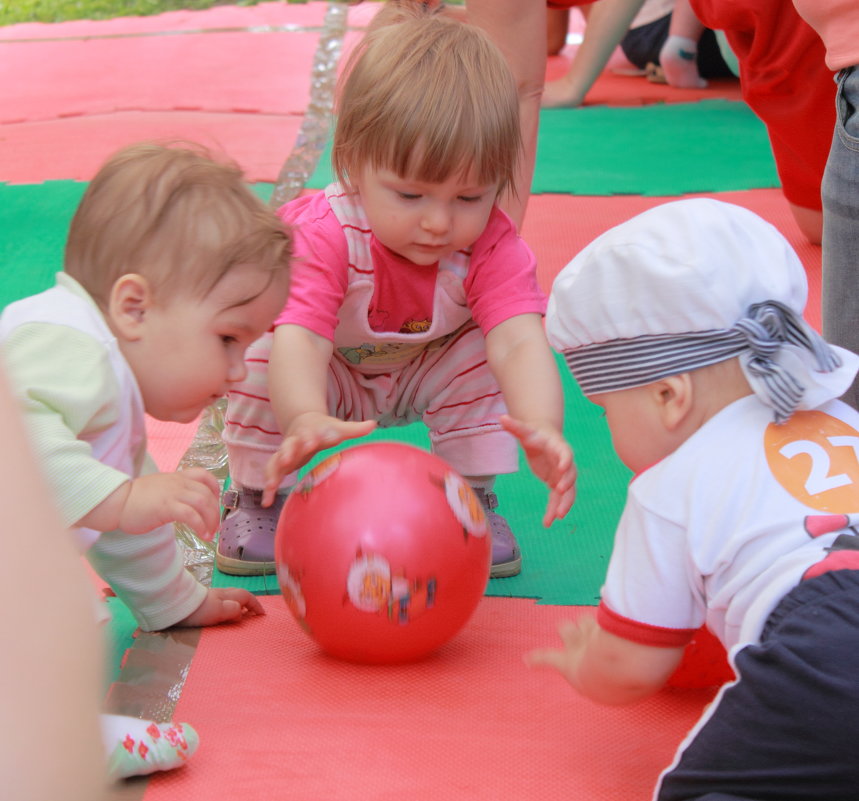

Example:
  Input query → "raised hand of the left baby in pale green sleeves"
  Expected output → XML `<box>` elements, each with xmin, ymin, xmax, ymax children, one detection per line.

<box><xmin>116</xmin><ymin>467</ymin><xmax>220</xmax><ymax>540</ymax></box>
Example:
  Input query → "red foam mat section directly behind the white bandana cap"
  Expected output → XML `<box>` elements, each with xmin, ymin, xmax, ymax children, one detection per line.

<box><xmin>522</xmin><ymin>189</ymin><xmax>820</xmax><ymax>330</ymax></box>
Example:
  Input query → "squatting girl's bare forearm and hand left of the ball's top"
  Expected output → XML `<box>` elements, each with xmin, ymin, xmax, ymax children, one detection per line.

<box><xmin>262</xmin><ymin>324</ymin><xmax>376</xmax><ymax>506</ymax></box>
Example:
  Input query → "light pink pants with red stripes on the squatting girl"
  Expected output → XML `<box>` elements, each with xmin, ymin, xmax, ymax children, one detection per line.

<box><xmin>223</xmin><ymin>323</ymin><xmax>519</xmax><ymax>489</ymax></box>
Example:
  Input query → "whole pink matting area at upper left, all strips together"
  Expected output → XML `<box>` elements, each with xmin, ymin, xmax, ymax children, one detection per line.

<box><xmin>0</xmin><ymin>2</ymin><xmax>368</xmax><ymax>183</ymax></box>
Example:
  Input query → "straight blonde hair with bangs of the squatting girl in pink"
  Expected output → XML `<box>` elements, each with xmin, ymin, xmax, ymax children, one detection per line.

<box><xmin>332</xmin><ymin>0</ymin><xmax>521</xmax><ymax>191</ymax></box>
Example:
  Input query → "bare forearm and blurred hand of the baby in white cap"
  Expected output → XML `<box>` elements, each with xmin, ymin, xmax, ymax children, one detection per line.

<box><xmin>525</xmin><ymin>615</ymin><xmax>684</xmax><ymax>705</ymax></box>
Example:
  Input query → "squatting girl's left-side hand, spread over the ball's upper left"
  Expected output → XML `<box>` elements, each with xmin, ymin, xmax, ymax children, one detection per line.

<box><xmin>262</xmin><ymin>412</ymin><xmax>376</xmax><ymax>506</ymax></box>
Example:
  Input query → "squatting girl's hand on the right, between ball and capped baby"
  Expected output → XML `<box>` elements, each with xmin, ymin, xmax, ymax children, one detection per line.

<box><xmin>501</xmin><ymin>414</ymin><xmax>576</xmax><ymax>526</ymax></box>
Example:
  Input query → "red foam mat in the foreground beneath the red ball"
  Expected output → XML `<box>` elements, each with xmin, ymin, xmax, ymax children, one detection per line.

<box><xmin>144</xmin><ymin>596</ymin><xmax>712</xmax><ymax>801</ymax></box>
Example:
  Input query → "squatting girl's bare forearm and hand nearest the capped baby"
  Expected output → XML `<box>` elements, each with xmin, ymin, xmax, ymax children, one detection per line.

<box><xmin>486</xmin><ymin>314</ymin><xmax>576</xmax><ymax>526</ymax></box>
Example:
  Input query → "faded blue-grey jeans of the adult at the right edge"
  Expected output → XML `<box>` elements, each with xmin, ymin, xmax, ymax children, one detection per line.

<box><xmin>821</xmin><ymin>66</ymin><xmax>859</xmax><ymax>408</ymax></box>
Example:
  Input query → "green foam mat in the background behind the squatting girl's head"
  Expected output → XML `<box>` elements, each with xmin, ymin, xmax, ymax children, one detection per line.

<box><xmin>307</xmin><ymin>100</ymin><xmax>780</xmax><ymax>196</ymax></box>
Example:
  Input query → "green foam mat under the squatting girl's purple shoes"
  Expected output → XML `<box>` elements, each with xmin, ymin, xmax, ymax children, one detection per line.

<box><xmin>212</xmin><ymin>357</ymin><xmax>630</xmax><ymax>606</ymax></box>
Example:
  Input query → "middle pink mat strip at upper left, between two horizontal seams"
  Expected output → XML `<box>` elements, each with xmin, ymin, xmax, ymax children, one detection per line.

<box><xmin>0</xmin><ymin>32</ymin><xmax>319</xmax><ymax>122</ymax></box>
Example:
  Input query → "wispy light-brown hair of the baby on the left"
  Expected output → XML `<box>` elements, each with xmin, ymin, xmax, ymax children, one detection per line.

<box><xmin>64</xmin><ymin>142</ymin><xmax>292</xmax><ymax>309</ymax></box>
